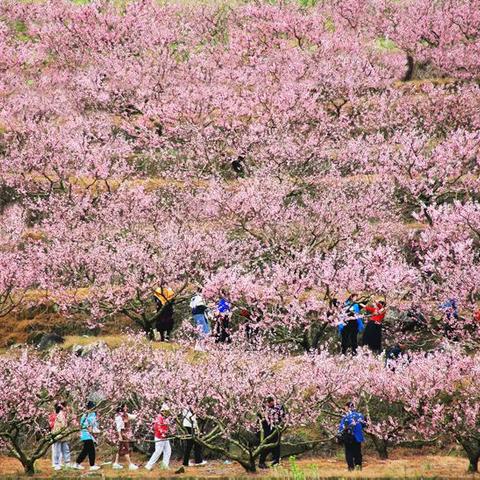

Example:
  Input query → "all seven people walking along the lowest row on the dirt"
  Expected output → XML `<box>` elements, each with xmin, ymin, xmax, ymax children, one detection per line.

<box><xmin>49</xmin><ymin>396</ymin><xmax>366</xmax><ymax>471</ymax></box>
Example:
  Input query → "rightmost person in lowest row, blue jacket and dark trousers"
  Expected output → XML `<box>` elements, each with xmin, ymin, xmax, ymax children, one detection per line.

<box><xmin>338</xmin><ymin>402</ymin><xmax>366</xmax><ymax>471</ymax></box>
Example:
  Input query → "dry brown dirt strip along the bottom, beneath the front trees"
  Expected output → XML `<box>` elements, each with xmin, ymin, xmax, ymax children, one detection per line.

<box><xmin>0</xmin><ymin>452</ymin><xmax>480</xmax><ymax>480</ymax></box>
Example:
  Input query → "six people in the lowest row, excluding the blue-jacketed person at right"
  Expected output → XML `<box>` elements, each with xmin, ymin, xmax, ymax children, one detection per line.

<box><xmin>48</xmin><ymin>397</ymin><xmax>284</xmax><ymax>471</ymax></box>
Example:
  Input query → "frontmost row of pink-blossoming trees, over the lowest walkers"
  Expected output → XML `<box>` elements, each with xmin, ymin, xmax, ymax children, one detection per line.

<box><xmin>0</xmin><ymin>344</ymin><xmax>480</xmax><ymax>473</ymax></box>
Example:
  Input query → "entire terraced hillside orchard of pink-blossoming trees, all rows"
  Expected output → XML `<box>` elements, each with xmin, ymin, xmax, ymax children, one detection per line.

<box><xmin>0</xmin><ymin>0</ymin><xmax>480</xmax><ymax>473</ymax></box>
